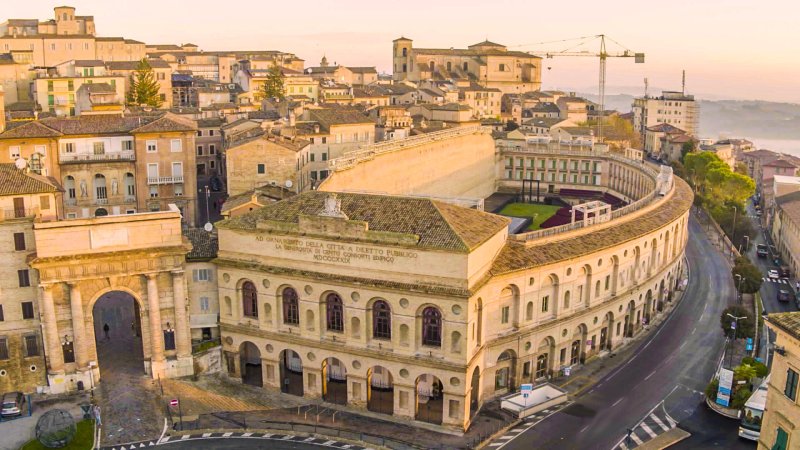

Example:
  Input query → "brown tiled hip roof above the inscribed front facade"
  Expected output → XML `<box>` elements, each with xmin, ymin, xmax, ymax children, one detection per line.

<box><xmin>220</xmin><ymin>191</ymin><xmax>508</xmax><ymax>253</ymax></box>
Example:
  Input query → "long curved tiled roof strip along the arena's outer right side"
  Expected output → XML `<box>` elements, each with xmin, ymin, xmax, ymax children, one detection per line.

<box><xmin>491</xmin><ymin>177</ymin><xmax>694</xmax><ymax>275</ymax></box>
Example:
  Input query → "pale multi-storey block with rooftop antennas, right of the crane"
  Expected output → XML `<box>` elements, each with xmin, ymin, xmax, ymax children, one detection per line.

<box><xmin>633</xmin><ymin>91</ymin><xmax>700</xmax><ymax>140</ymax></box>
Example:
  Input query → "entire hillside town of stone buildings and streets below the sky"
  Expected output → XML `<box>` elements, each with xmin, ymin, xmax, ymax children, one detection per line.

<box><xmin>0</xmin><ymin>6</ymin><xmax>800</xmax><ymax>450</ymax></box>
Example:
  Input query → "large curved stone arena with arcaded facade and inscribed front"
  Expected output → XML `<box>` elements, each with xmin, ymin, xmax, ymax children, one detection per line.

<box><xmin>216</xmin><ymin>126</ymin><xmax>692</xmax><ymax>429</ymax></box>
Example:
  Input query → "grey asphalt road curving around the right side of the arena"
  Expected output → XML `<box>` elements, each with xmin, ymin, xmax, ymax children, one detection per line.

<box><xmin>492</xmin><ymin>218</ymin><xmax>754</xmax><ymax>450</ymax></box>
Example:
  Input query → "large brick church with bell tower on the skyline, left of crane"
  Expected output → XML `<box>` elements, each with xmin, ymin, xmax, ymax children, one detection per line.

<box><xmin>392</xmin><ymin>37</ymin><xmax>542</xmax><ymax>94</ymax></box>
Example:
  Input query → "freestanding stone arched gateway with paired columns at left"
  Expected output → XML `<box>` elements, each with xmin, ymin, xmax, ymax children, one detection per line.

<box><xmin>31</xmin><ymin>207</ymin><xmax>193</xmax><ymax>393</ymax></box>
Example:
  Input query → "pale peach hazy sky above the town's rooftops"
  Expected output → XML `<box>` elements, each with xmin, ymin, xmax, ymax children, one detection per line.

<box><xmin>7</xmin><ymin>0</ymin><xmax>800</xmax><ymax>102</ymax></box>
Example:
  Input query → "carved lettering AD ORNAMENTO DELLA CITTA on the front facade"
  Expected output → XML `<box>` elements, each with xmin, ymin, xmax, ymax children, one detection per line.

<box><xmin>256</xmin><ymin>236</ymin><xmax>418</xmax><ymax>264</ymax></box>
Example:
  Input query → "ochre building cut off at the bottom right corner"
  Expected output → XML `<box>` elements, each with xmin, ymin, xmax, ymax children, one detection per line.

<box><xmin>758</xmin><ymin>312</ymin><xmax>800</xmax><ymax>450</ymax></box>
